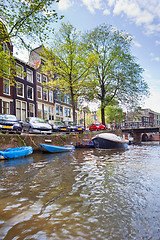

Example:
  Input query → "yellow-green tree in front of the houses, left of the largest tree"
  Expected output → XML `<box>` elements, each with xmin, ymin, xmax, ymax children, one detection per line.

<box><xmin>42</xmin><ymin>23</ymin><xmax>96</xmax><ymax>121</ymax></box>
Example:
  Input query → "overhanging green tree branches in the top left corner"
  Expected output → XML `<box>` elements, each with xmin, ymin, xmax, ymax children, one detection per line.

<box><xmin>0</xmin><ymin>0</ymin><xmax>61</xmax><ymax>83</ymax></box>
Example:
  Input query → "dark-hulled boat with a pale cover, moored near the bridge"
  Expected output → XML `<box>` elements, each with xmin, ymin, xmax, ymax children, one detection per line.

<box><xmin>92</xmin><ymin>133</ymin><xmax>129</xmax><ymax>149</ymax></box>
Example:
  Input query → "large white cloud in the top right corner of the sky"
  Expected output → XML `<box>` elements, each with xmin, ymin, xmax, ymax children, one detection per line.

<box><xmin>108</xmin><ymin>0</ymin><xmax>160</xmax><ymax>34</ymax></box>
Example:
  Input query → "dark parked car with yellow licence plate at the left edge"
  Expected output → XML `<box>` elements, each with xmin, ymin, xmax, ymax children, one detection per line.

<box><xmin>0</xmin><ymin>114</ymin><xmax>22</xmax><ymax>134</ymax></box>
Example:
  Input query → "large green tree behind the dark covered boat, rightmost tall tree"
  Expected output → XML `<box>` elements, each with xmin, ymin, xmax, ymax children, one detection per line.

<box><xmin>84</xmin><ymin>25</ymin><xmax>148</xmax><ymax>124</ymax></box>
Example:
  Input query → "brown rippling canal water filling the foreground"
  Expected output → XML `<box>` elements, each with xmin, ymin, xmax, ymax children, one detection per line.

<box><xmin>0</xmin><ymin>144</ymin><xmax>160</xmax><ymax>240</ymax></box>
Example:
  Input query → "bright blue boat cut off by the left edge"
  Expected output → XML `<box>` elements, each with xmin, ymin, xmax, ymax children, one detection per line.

<box><xmin>0</xmin><ymin>146</ymin><xmax>33</xmax><ymax>159</ymax></box>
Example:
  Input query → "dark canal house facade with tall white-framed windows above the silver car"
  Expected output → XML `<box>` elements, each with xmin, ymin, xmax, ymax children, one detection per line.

<box><xmin>13</xmin><ymin>59</ymin><xmax>37</xmax><ymax>121</ymax></box>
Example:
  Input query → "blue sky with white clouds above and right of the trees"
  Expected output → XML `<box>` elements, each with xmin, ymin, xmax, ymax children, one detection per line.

<box><xmin>15</xmin><ymin>0</ymin><xmax>160</xmax><ymax>113</ymax></box>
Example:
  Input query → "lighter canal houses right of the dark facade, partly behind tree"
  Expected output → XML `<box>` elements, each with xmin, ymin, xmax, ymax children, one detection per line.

<box><xmin>29</xmin><ymin>46</ymin><xmax>79</xmax><ymax>121</ymax></box>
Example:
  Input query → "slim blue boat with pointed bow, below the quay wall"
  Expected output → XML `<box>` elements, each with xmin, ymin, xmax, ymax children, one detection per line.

<box><xmin>39</xmin><ymin>143</ymin><xmax>75</xmax><ymax>153</ymax></box>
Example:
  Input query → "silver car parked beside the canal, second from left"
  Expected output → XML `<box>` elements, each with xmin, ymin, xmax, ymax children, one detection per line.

<box><xmin>22</xmin><ymin>117</ymin><xmax>52</xmax><ymax>134</ymax></box>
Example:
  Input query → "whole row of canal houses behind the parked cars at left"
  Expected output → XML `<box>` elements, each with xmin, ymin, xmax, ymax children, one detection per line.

<box><xmin>0</xmin><ymin>19</ymin><xmax>79</xmax><ymax>121</ymax></box>
